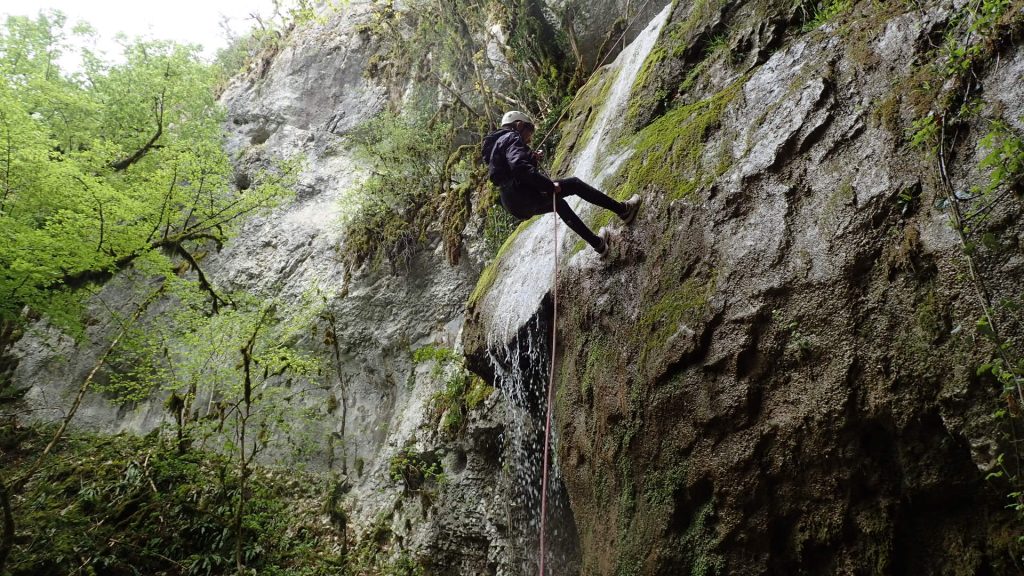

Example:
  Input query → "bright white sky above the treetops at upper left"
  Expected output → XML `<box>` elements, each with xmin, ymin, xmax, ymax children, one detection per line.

<box><xmin>0</xmin><ymin>0</ymin><xmax>273</xmax><ymax>63</ymax></box>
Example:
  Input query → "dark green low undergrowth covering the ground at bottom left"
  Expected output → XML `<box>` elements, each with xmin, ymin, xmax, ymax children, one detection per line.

<box><xmin>3</xmin><ymin>430</ymin><xmax>342</xmax><ymax>576</ymax></box>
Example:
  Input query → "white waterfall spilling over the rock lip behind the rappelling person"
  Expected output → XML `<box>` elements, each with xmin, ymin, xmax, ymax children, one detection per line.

<box><xmin>480</xmin><ymin>5</ymin><xmax>671</xmax><ymax>575</ymax></box>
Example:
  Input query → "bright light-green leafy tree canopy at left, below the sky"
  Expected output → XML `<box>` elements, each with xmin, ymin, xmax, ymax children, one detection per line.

<box><xmin>0</xmin><ymin>13</ymin><xmax>296</xmax><ymax>332</ymax></box>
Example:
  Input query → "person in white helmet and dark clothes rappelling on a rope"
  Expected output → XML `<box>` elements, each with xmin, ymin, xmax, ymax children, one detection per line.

<box><xmin>482</xmin><ymin>111</ymin><xmax>640</xmax><ymax>258</ymax></box>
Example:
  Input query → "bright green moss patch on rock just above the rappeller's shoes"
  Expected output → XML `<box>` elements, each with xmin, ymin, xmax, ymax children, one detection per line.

<box><xmin>615</xmin><ymin>79</ymin><xmax>743</xmax><ymax>200</ymax></box>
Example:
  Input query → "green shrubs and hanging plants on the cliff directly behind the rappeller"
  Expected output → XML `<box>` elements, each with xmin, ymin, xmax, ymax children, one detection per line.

<box><xmin>345</xmin><ymin>0</ymin><xmax>583</xmax><ymax>266</ymax></box>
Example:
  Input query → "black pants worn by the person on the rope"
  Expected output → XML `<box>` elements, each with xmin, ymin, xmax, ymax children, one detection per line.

<box><xmin>501</xmin><ymin>177</ymin><xmax>626</xmax><ymax>250</ymax></box>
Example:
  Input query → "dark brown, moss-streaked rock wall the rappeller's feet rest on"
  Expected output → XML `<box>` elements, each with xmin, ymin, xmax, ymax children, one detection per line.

<box><xmin>466</xmin><ymin>2</ymin><xmax>1024</xmax><ymax>574</ymax></box>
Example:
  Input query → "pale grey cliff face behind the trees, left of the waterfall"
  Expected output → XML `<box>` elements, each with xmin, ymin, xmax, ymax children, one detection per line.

<box><xmin>8</xmin><ymin>2</ymin><xmax>522</xmax><ymax>574</ymax></box>
